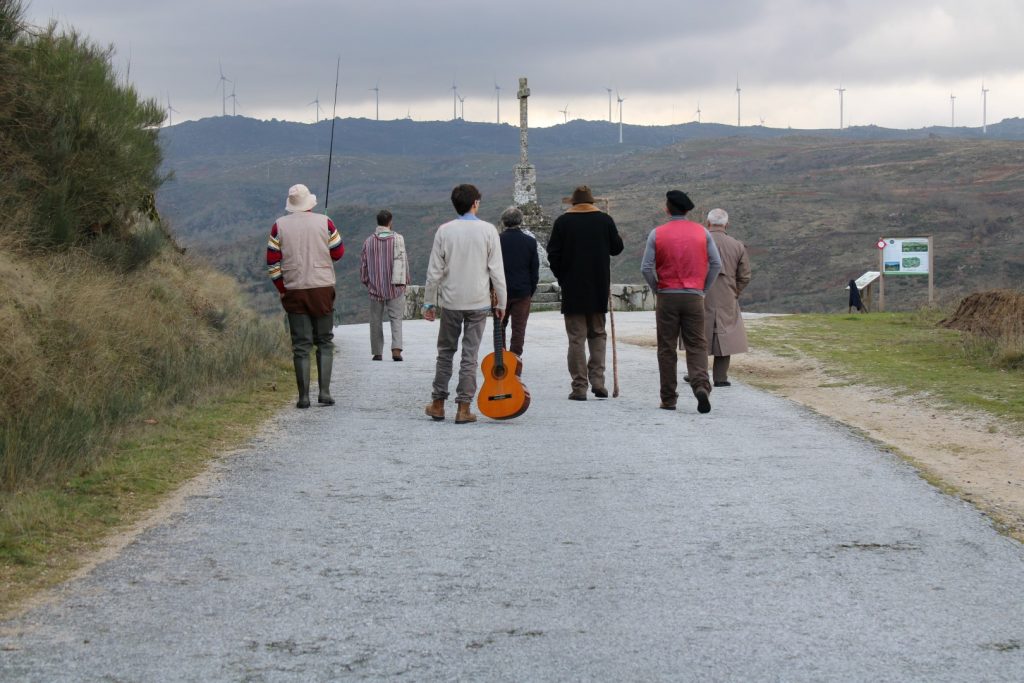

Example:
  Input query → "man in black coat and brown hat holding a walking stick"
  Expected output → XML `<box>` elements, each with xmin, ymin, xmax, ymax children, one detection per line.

<box><xmin>548</xmin><ymin>185</ymin><xmax>623</xmax><ymax>400</ymax></box>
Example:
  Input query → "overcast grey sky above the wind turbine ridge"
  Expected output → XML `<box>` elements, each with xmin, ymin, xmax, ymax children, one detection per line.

<box><xmin>28</xmin><ymin>0</ymin><xmax>1024</xmax><ymax>128</ymax></box>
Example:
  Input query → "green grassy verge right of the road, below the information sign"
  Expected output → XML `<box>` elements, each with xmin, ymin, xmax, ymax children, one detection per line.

<box><xmin>748</xmin><ymin>310</ymin><xmax>1024</xmax><ymax>426</ymax></box>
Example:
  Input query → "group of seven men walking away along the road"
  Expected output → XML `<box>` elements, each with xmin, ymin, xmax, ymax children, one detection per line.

<box><xmin>267</xmin><ymin>184</ymin><xmax>751</xmax><ymax>417</ymax></box>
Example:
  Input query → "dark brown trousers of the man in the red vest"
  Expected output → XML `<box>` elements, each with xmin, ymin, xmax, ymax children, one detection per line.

<box><xmin>654</xmin><ymin>294</ymin><xmax>711</xmax><ymax>405</ymax></box>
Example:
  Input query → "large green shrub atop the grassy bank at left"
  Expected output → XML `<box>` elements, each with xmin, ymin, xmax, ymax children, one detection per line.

<box><xmin>0</xmin><ymin>0</ymin><xmax>164</xmax><ymax>249</ymax></box>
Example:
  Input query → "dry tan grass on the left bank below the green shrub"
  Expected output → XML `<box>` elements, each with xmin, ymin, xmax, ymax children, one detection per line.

<box><xmin>0</xmin><ymin>250</ymin><xmax>283</xmax><ymax>490</ymax></box>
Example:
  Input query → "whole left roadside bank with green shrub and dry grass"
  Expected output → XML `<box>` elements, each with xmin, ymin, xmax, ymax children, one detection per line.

<box><xmin>0</xmin><ymin>0</ymin><xmax>285</xmax><ymax>491</ymax></box>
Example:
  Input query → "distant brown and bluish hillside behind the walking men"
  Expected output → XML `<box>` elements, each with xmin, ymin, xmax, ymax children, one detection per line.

<box><xmin>158</xmin><ymin>117</ymin><xmax>1024</xmax><ymax>322</ymax></box>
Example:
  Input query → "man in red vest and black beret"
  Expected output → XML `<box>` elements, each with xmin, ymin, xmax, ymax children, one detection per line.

<box><xmin>640</xmin><ymin>189</ymin><xmax>722</xmax><ymax>413</ymax></box>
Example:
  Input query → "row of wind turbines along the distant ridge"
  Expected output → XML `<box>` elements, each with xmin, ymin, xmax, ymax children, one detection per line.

<box><xmin>167</xmin><ymin>66</ymin><xmax>991</xmax><ymax>136</ymax></box>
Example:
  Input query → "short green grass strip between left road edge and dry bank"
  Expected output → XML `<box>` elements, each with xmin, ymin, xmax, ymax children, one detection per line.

<box><xmin>0</xmin><ymin>362</ymin><xmax>294</xmax><ymax>614</ymax></box>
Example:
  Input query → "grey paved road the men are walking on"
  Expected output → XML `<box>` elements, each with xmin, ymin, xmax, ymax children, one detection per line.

<box><xmin>0</xmin><ymin>313</ymin><xmax>1024</xmax><ymax>681</ymax></box>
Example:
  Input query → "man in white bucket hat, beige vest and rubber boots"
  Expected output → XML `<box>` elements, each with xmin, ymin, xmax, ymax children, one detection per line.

<box><xmin>266</xmin><ymin>184</ymin><xmax>345</xmax><ymax>408</ymax></box>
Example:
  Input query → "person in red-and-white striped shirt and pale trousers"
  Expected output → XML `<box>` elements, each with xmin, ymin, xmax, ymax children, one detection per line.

<box><xmin>359</xmin><ymin>209</ymin><xmax>412</xmax><ymax>360</ymax></box>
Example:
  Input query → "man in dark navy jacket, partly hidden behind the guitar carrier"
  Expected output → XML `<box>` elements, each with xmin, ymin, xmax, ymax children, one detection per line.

<box><xmin>498</xmin><ymin>206</ymin><xmax>541</xmax><ymax>355</ymax></box>
